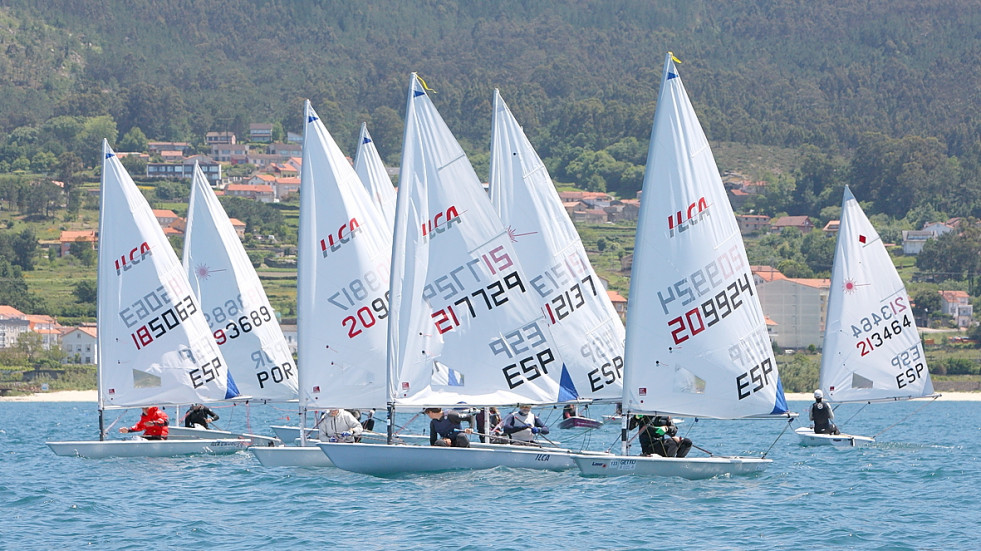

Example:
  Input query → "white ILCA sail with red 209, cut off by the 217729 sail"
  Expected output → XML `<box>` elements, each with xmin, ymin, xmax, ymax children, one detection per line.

<box><xmin>297</xmin><ymin>101</ymin><xmax>392</xmax><ymax>408</ymax></box>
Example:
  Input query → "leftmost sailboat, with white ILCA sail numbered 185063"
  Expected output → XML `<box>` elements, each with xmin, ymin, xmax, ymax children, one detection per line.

<box><xmin>47</xmin><ymin>140</ymin><xmax>248</xmax><ymax>458</ymax></box>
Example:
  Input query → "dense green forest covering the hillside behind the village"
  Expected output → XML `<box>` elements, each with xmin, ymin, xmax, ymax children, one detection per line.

<box><xmin>0</xmin><ymin>0</ymin><xmax>981</xmax><ymax>332</ymax></box>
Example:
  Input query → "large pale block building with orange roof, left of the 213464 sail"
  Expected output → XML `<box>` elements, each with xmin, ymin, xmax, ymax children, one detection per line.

<box><xmin>753</xmin><ymin>268</ymin><xmax>831</xmax><ymax>349</ymax></box>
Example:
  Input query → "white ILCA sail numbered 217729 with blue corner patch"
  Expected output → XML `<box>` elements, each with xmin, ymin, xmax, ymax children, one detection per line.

<box><xmin>388</xmin><ymin>74</ymin><xmax>574</xmax><ymax>406</ymax></box>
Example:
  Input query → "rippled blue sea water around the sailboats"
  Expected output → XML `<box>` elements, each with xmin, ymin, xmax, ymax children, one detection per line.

<box><xmin>0</xmin><ymin>402</ymin><xmax>981</xmax><ymax>549</ymax></box>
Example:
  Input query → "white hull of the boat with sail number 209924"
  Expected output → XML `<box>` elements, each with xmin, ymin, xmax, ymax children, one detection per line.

<box><xmin>573</xmin><ymin>455</ymin><xmax>773</xmax><ymax>480</ymax></box>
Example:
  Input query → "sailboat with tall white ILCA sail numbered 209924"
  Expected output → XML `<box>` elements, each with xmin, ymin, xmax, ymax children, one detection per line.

<box><xmin>576</xmin><ymin>53</ymin><xmax>787</xmax><ymax>479</ymax></box>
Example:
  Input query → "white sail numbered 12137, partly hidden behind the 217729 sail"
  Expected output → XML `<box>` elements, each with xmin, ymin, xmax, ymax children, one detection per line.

<box><xmin>490</xmin><ymin>90</ymin><xmax>624</xmax><ymax>400</ymax></box>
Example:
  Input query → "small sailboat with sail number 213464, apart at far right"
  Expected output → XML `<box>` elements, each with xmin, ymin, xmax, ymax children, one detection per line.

<box><xmin>796</xmin><ymin>187</ymin><xmax>939</xmax><ymax>447</ymax></box>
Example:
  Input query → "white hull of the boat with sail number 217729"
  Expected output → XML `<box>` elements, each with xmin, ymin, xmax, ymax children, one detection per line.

<box><xmin>319</xmin><ymin>443</ymin><xmax>588</xmax><ymax>475</ymax></box>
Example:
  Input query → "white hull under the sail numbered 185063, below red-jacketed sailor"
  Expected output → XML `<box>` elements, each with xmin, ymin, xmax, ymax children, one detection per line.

<box><xmin>46</xmin><ymin>439</ymin><xmax>249</xmax><ymax>459</ymax></box>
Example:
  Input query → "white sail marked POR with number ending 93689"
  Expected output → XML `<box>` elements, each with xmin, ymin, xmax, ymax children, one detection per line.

<box><xmin>183</xmin><ymin>163</ymin><xmax>297</xmax><ymax>401</ymax></box>
